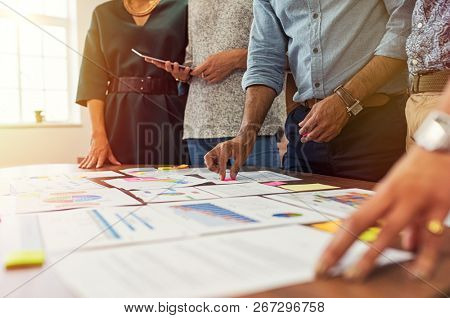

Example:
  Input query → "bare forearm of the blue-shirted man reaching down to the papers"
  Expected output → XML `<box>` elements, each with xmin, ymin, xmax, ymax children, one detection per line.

<box><xmin>239</xmin><ymin>85</ymin><xmax>276</xmax><ymax>135</ymax></box>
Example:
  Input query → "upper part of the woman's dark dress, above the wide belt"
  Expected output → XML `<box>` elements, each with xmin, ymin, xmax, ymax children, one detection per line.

<box><xmin>77</xmin><ymin>0</ymin><xmax>187</xmax><ymax>106</ymax></box>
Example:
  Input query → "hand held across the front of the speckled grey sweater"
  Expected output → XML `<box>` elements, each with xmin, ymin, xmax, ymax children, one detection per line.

<box><xmin>191</xmin><ymin>49</ymin><xmax>247</xmax><ymax>84</ymax></box>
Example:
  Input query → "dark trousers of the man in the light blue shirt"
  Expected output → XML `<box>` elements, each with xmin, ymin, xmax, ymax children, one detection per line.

<box><xmin>284</xmin><ymin>95</ymin><xmax>407</xmax><ymax>181</ymax></box>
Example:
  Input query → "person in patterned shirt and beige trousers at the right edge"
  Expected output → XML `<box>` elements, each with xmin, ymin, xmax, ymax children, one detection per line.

<box><xmin>406</xmin><ymin>0</ymin><xmax>450</xmax><ymax>148</ymax></box>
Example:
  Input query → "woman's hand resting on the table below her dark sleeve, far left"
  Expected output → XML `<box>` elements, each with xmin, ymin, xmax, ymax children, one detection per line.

<box><xmin>79</xmin><ymin>134</ymin><xmax>121</xmax><ymax>169</ymax></box>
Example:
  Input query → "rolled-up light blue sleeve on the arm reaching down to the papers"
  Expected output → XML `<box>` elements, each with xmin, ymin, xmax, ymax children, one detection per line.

<box><xmin>242</xmin><ymin>0</ymin><xmax>287</xmax><ymax>94</ymax></box>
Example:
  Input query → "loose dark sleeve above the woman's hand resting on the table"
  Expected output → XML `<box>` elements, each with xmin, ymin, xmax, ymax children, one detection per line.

<box><xmin>76</xmin><ymin>11</ymin><xmax>109</xmax><ymax>106</ymax></box>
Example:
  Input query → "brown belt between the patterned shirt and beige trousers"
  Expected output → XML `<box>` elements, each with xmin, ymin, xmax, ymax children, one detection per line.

<box><xmin>410</xmin><ymin>70</ymin><xmax>450</xmax><ymax>94</ymax></box>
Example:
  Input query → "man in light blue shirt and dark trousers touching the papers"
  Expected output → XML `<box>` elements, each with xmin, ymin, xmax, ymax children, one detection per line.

<box><xmin>206</xmin><ymin>0</ymin><xmax>414</xmax><ymax>181</ymax></box>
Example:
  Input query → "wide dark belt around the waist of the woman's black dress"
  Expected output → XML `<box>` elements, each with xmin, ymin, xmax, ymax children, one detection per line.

<box><xmin>108</xmin><ymin>77</ymin><xmax>178</xmax><ymax>95</ymax></box>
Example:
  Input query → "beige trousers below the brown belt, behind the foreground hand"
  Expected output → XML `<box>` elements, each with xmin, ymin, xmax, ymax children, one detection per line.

<box><xmin>406</xmin><ymin>93</ymin><xmax>442</xmax><ymax>150</ymax></box>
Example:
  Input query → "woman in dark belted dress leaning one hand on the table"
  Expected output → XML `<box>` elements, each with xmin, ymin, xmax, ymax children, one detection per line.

<box><xmin>77</xmin><ymin>0</ymin><xmax>187</xmax><ymax>168</ymax></box>
